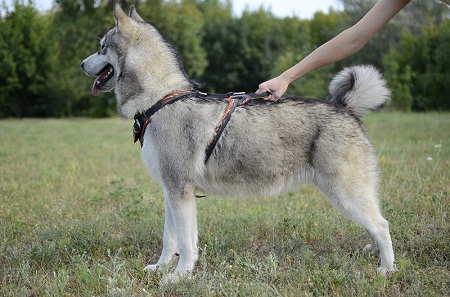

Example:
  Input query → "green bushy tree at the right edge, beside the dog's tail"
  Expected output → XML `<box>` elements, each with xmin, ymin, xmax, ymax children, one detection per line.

<box><xmin>384</xmin><ymin>20</ymin><xmax>450</xmax><ymax>111</ymax></box>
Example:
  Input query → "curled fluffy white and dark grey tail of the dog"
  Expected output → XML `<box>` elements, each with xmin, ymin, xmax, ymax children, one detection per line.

<box><xmin>328</xmin><ymin>66</ymin><xmax>390</xmax><ymax>118</ymax></box>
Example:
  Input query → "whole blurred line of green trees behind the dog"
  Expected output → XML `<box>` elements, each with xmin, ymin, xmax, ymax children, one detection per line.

<box><xmin>0</xmin><ymin>0</ymin><xmax>450</xmax><ymax>118</ymax></box>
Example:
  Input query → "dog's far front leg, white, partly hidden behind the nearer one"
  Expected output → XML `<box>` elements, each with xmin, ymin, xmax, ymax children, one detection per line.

<box><xmin>144</xmin><ymin>190</ymin><xmax>178</xmax><ymax>271</ymax></box>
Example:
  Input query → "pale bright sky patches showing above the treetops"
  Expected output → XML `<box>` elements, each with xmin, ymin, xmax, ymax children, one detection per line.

<box><xmin>6</xmin><ymin>0</ymin><xmax>340</xmax><ymax>19</ymax></box>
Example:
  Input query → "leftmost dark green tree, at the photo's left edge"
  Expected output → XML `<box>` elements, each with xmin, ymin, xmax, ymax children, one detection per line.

<box><xmin>0</xmin><ymin>0</ymin><xmax>60</xmax><ymax>117</ymax></box>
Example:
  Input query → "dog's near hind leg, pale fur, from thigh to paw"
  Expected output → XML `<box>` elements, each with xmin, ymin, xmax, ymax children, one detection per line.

<box><xmin>318</xmin><ymin>174</ymin><xmax>396</xmax><ymax>275</ymax></box>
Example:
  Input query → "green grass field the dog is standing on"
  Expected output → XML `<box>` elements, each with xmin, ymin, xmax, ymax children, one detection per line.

<box><xmin>0</xmin><ymin>113</ymin><xmax>450</xmax><ymax>296</ymax></box>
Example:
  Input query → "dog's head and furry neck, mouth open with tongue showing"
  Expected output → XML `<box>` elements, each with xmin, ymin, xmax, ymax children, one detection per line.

<box><xmin>81</xmin><ymin>3</ymin><xmax>193</xmax><ymax>118</ymax></box>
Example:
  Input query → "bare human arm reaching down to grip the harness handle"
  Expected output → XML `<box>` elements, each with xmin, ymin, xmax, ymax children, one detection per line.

<box><xmin>256</xmin><ymin>0</ymin><xmax>411</xmax><ymax>101</ymax></box>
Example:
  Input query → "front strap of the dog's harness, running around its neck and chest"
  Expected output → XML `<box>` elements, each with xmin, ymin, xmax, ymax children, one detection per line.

<box><xmin>133</xmin><ymin>90</ymin><xmax>197</xmax><ymax>147</ymax></box>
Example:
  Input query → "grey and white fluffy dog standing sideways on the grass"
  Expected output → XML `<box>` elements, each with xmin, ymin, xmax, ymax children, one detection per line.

<box><xmin>81</xmin><ymin>4</ymin><xmax>395</xmax><ymax>280</ymax></box>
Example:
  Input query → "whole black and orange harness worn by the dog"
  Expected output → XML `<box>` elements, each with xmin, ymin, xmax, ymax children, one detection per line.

<box><xmin>133</xmin><ymin>91</ymin><xmax>269</xmax><ymax>164</ymax></box>
